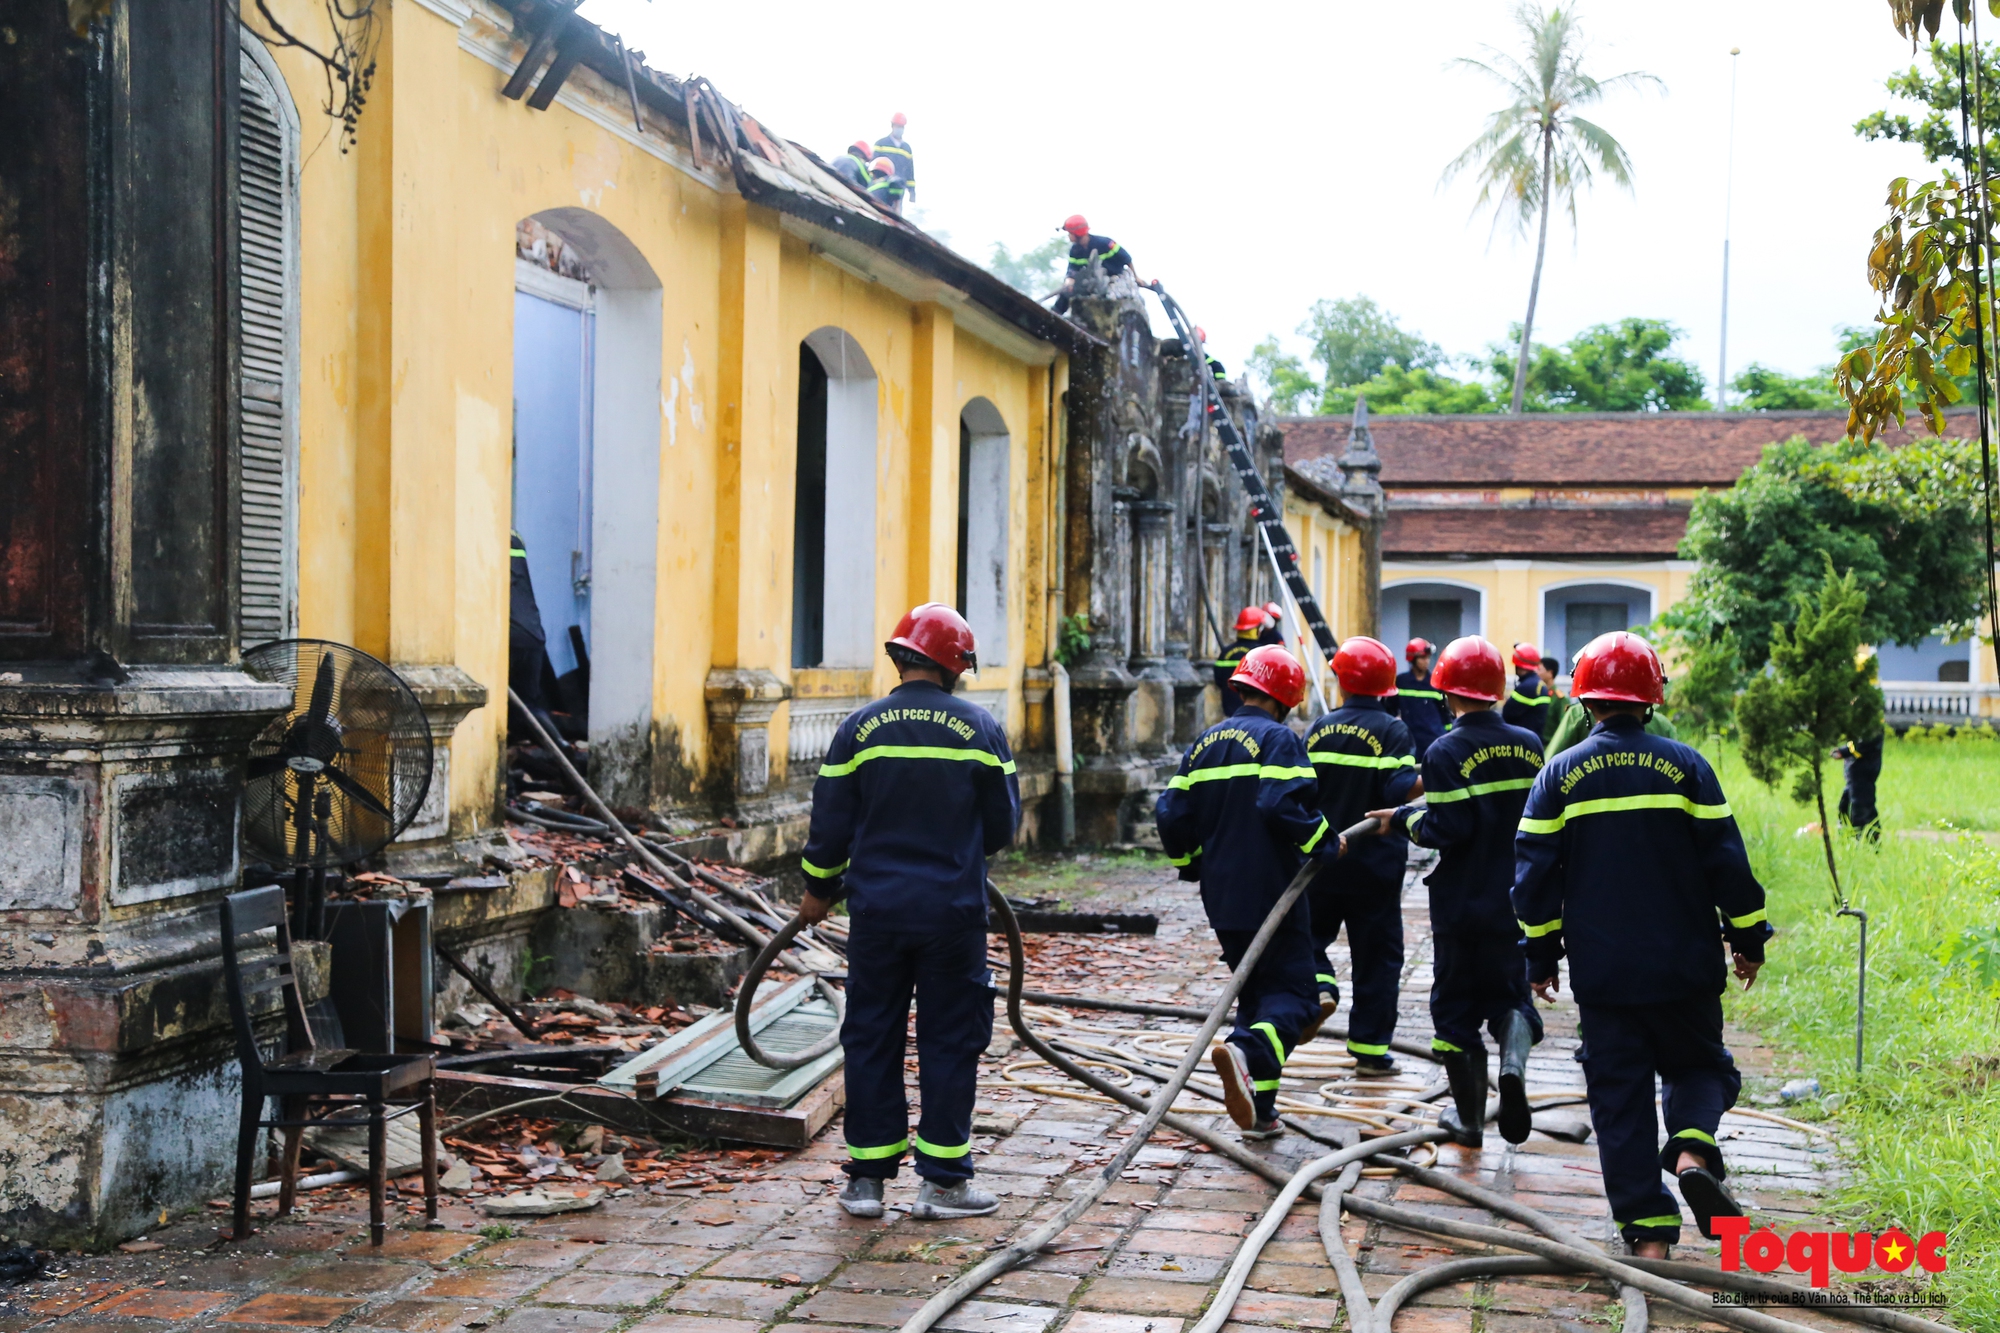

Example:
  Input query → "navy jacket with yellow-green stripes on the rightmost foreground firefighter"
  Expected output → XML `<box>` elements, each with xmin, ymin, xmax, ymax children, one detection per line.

<box><xmin>1514</xmin><ymin>715</ymin><xmax>1770</xmax><ymax>1005</ymax></box>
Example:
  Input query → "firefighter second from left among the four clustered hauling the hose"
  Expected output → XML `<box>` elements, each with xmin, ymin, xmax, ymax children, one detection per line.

<box><xmin>1306</xmin><ymin>638</ymin><xmax>1416</xmax><ymax>1079</ymax></box>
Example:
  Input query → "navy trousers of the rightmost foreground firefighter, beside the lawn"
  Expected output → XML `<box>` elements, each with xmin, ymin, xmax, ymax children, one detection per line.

<box><xmin>1576</xmin><ymin>997</ymin><xmax>1742</xmax><ymax>1245</ymax></box>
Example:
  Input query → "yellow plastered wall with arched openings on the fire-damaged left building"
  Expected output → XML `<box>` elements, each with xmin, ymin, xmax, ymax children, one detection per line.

<box><xmin>272</xmin><ymin>0</ymin><xmax>1060</xmax><ymax>831</ymax></box>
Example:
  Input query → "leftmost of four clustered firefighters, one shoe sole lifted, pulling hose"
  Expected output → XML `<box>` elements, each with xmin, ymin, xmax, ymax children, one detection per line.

<box><xmin>1154</xmin><ymin>646</ymin><xmax>1338</xmax><ymax>1139</ymax></box>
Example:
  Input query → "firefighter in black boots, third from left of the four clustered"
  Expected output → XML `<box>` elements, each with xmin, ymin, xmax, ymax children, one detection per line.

<box><xmin>1372</xmin><ymin>634</ymin><xmax>1542</xmax><ymax>1147</ymax></box>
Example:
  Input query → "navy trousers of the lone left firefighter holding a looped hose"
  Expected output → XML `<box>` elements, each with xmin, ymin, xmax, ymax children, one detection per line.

<box><xmin>840</xmin><ymin>921</ymin><xmax>994</xmax><ymax>1183</ymax></box>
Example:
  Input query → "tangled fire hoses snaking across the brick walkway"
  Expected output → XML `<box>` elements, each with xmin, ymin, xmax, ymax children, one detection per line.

<box><xmin>736</xmin><ymin>823</ymin><xmax>1956</xmax><ymax>1333</ymax></box>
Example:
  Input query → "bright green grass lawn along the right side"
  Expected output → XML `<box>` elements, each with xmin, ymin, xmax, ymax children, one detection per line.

<box><xmin>1708</xmin><ymin>737</ymin><xmax>2000</xmax><ymax>1329</ymax></box>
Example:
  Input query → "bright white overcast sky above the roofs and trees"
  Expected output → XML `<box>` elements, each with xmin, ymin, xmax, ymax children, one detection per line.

<box><xmin>584</xmin><ymin>0</ymin><xmax>1952</xmax><ymax>400</ymax></box>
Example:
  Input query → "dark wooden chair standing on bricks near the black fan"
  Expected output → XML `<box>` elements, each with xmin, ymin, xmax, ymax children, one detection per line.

<box><xmin>222</xmin><ymin>885</ymin><xmax>438</xmax><ymax>1245</ymax></box>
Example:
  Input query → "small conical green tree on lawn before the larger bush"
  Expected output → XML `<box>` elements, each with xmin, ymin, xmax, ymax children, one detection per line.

<box><xmin>1736</xmin><ymin>556</ymin><xmax>1882</xmax><ymax>907</ymax></box>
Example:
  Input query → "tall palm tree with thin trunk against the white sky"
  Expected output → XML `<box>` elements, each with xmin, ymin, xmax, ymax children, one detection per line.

<box><xmin>1444</xmin><ymin>4</ymin><xmax>1660</xmax><ymax>414</ymax></box>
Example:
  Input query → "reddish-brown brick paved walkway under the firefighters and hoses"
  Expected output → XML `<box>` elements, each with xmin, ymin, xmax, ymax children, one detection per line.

<box><xmin>0</xmin><ymin>859</ymin><xmax>1838</xmax><ymax>1333</ymax></box>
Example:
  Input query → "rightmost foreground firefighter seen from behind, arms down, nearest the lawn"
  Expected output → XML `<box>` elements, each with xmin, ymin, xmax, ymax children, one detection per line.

<box><xmin>1514</xmin><ymin>630</ymin><xmax>1772</xmax><ymax>1259</ymax></box>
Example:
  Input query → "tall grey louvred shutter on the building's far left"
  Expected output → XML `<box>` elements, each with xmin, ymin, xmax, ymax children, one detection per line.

<box><xmin>238</xmin><ymin>50</ymin><xmax>298</xmax><ymax>646</ymax></box>
